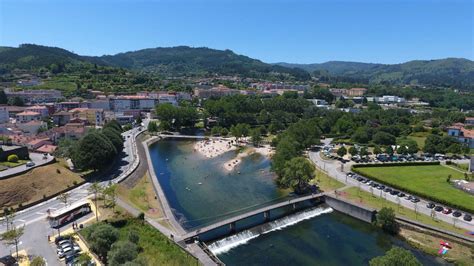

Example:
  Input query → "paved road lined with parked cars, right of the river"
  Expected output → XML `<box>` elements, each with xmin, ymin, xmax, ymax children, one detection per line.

<box><xmin>309</xmin><ymin>152</ymin><xmax>474</xmax><ymax>231</ymax></box>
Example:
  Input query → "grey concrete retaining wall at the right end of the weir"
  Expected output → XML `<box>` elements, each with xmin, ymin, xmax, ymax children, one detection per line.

<box><xmin>325</xmin><ymin>195</ymin><xmax>377</xmax><ymax>223</ymax></box>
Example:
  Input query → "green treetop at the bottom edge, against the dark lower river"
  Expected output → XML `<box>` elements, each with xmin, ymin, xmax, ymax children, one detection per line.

<box><xmin>369</xmin><ymin>247</ymin><xmax>422</xmax><ymax>266</ymax></box>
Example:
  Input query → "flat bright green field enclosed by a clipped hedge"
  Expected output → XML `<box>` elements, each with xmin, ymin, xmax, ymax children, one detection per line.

<box><xmin>354</xmin><ymin>165</ymin><xmax>474</xmax><ymax>213</ymax></box>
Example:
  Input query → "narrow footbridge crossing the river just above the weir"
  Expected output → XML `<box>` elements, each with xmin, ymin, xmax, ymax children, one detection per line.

<box><xmin>176</xmin><ymin>193</ymin><xmax>325</xmax><ymax>241</ymax></box>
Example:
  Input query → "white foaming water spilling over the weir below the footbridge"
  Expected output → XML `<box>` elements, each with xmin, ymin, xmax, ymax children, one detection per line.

<box><xmin>208</xmin><ymin>207</ymin><xmax>332</xmax><ymax>255</ymax></box>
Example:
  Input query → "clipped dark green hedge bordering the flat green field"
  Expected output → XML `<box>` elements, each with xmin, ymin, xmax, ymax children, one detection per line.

<box><xmin>352</xmin><ymin>162</ymin><xmax>474</xmax><ymax>214</ymax></box>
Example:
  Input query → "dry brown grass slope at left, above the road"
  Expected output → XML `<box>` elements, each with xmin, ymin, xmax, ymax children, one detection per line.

<box><xmin>0</xmin><ymin>163</ymin><xmax>83</xmax><ymax>207</ymax></box>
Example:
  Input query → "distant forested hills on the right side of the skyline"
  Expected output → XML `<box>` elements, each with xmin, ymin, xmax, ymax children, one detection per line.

<box><xmin>277</xmin><ymin>58</ymin><xmax>474</xmax><ymax>90</ymax></box>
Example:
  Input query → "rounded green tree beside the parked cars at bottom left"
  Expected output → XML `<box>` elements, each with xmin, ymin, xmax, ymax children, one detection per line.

<box><xmin>87</xmin><ymin>224</ymin><xmax>119</xmax><ymax>260</ymax></box>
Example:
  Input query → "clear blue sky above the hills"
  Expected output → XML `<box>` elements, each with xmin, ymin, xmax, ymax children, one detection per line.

<box><xmin>0</xmin><ymin>0</ymin><xmax>474</xmax><ymax>63</ymax></box>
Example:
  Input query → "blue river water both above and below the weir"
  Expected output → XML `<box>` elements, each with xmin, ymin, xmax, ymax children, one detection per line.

<box><xmin>150</xmin><ymin>140</ymin><xmax>442</xmax><ymax>265</ymax></box>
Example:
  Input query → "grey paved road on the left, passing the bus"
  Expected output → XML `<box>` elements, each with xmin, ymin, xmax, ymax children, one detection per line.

<box><xmin>0</xmin><ymin>125</ymin><xmax>143</xmax><ymax>266</ymax></box>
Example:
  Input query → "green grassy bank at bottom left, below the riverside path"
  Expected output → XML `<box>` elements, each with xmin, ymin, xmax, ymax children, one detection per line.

<box><xmin>80</xmin><ymin>218</ymin><xmax>197</xmax><ymax>265</ymax></box>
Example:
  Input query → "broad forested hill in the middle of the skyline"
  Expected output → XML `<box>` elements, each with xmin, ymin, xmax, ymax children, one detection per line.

<box><xmin>91</xmin><ymin>46</ymin><xmax>310</xmax><ymax>80</ymax></box>
